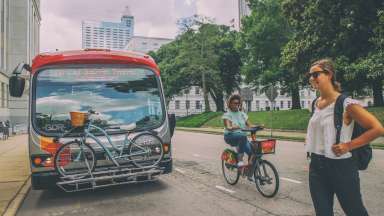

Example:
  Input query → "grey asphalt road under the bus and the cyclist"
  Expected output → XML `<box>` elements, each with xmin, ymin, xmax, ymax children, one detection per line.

<box><xmin>18</xmin><ymin>131</ymin><xmax>384</xmax><ymax>216</ymax></box>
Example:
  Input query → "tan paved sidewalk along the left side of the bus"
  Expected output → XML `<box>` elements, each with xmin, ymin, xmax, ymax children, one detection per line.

<box><xmin>0</xmin><ymin>134</ymin><xmax>30</xmax><ymax>215</ymax></box>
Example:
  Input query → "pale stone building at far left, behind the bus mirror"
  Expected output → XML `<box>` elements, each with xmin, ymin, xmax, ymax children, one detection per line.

<box><xmin>0</xmin><ymin>0</ymin><xmax>41</xmax><ymax>124</ymax></box>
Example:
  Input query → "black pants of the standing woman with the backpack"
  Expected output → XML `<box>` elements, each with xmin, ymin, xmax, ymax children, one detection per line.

<box><xmin>309</xmin><ymin>154</ymin><xmax>368</xmax><ymax>216</ymax></box>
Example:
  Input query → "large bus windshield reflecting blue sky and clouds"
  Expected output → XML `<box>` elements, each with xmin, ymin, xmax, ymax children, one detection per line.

<box><xmin>32</xmin><ymin>65</ymin><xmax>164</xmax><ymax>133</ymax></box>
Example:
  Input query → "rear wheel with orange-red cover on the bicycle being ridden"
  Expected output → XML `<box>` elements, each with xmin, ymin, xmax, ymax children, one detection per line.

<box><xmin>221</xmin><ymin>151</ymin><xmax>240</xmax><ymax>185</ymax></box>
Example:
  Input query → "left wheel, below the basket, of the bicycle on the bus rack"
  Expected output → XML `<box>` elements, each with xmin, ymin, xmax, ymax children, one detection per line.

<box><xmin>54</xmin><ymin>141</ymin><xmax>96</xmax><ymax>179</ymax></box>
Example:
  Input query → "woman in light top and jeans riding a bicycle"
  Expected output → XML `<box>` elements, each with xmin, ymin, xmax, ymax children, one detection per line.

<box><xmin>222</xmin><ymin>94</ymin><xmax>254</xmax><ymax>167</ymax></box>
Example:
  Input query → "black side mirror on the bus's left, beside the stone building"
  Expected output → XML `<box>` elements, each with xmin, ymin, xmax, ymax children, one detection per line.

<box><xmin>9</xmin><ymin>62</ymin><xmax>31</xmax><ymax>97</ymax></box>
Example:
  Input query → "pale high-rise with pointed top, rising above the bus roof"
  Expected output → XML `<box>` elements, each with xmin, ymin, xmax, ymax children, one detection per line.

<box><xmin>82</xmin><ymin>7</ymin><xmax>134</xmax><ymax>50</ymax></box>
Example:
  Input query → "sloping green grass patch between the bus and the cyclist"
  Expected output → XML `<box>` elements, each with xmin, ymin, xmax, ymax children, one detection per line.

<box><xmin>176</xmin><ymin>112</ymin><xmax>223</xmax><ymax>127</ymax></box>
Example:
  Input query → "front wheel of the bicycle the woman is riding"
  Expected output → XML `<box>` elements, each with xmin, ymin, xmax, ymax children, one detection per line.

<box><xmin>253</xmin><ymin>160</ymin><xmax>279</xmax><ymax>198</ymax></box>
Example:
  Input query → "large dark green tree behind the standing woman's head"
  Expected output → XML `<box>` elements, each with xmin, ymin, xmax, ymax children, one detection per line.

<box><xmin>282</xmin><ymin>0</ymin><xmax>383</xmax><ymax>105</ymax></box>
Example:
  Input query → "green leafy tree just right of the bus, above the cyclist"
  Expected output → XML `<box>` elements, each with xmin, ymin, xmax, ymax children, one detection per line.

<box><xmin>151</xmin><ymin>19</ymin><xmax>241</xmax><ymax>111</ymax></box>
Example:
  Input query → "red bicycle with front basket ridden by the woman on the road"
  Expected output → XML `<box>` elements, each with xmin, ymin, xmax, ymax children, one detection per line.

<box><xmin>221</xmin><ymin>126</ymin><xmax>279</xmax><ymax>198</ymax></box>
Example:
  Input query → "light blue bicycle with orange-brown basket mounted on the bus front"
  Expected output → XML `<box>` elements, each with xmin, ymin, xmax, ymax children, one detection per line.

<box><xmin>54</xmin><ymin>110</ymin><xmax>164</xmax><ymax>186</ymax></box>
